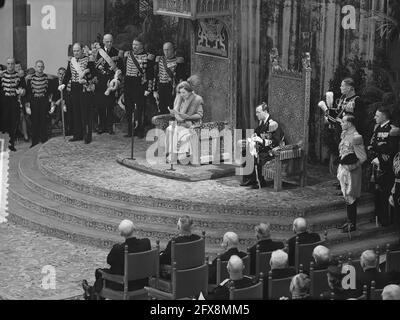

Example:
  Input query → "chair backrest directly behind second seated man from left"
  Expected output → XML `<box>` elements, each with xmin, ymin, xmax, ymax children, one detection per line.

<box><xmin>171</xmin><ymin>233</ymin><xmax>206</xmax><ymax>270</ymax></box>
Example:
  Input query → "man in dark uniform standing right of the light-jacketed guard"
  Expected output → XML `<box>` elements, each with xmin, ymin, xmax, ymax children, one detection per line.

<box><xmin>368</xmin><ymin>106</ymin><xmax>400</xmax><ymax>226</ymax></box>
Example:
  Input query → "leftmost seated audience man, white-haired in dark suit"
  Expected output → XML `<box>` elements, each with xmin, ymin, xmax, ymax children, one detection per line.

<box><xmin>82</xmin><ymin>220</ymin><xmax>151</xmax><ymax>300</ymax></box>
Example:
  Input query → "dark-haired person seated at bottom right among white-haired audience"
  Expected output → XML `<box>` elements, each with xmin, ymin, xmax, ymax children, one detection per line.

<box><xmin>322</xmin><ymin>265</ymin><xmax>360</xmax><ymax>300</ymax></box>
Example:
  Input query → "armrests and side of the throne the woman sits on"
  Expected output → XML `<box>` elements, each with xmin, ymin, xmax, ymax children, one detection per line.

<box><xmin>152</xmin><ymin>114</ymin><xmax>232</xmax><ymax>166</ymax></box>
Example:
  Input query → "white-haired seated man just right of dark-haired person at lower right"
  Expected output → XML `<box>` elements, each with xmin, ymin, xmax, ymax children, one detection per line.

<box><xmin>356</xmin><ymin>250</ymin><xmax>393</xmax><ymax>296</ymax></box>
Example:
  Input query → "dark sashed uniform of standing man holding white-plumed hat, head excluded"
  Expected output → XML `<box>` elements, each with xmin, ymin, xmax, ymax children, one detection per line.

<box><xmin>95</xmin><ymin>47</ymin><xmax>123</xmax><ymax>133</ymax></box>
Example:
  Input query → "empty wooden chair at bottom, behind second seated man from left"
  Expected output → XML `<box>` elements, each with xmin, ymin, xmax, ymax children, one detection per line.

<box><xmin>144</xmin><ymin>261</ymin><xmax>208</xmax><ymax>300</ymax></box>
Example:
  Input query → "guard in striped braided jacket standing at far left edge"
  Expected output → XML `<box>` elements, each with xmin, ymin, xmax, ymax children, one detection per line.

<box><xmin>0</xmin><ymin>58</ymin><xmax>26</xmax><ymax>151</ymax></box>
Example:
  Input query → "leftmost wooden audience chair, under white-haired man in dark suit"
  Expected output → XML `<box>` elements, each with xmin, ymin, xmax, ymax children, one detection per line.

<box><xmin>99</xmin><ymin>241</ymin><xmax>160</xmax><ymax>300</ymax></box>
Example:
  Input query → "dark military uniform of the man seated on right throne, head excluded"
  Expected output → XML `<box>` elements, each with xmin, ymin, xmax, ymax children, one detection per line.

<box><xmin>242</xmin><ymin>117</ymin><xmax>284</xmax><ymax>185</ymax></box>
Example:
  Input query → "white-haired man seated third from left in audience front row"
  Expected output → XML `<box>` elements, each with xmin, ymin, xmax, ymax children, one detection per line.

<box><xmin>208</xmin><ymin>232</ymin><xmax>247</xmax><ymax>283</ymax></box>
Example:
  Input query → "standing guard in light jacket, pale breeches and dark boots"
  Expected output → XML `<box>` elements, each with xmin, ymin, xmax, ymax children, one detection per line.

<box><xmin>337</xmin><ymin>115</ymin><xmax>367</xmax><ymax>232</ymax></box>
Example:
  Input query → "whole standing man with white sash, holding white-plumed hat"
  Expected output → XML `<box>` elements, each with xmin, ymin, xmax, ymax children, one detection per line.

<box><xmin>95</xmin><ymin>34</ymin><xmax>123</xmax><ymax>134</ymax></box>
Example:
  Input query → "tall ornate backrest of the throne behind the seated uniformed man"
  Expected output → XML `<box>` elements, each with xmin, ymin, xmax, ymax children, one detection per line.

<box><xmin>268</xmin><ymin>49</ymin><xmax>311</xmax><ymax>158</ymax></box>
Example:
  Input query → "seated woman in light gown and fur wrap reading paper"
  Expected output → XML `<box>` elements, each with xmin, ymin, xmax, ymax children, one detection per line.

<box><xmin>165</xmin><ymin>80</ymin><xmax>204</xmax><ymax>162</ymax></box>
